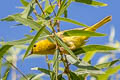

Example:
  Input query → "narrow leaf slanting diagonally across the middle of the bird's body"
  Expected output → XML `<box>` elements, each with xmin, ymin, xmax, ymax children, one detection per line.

<box><xmin>55</xmin><ymin>35</ymin><xmax>80</xmax><ymax>62</ymax></box>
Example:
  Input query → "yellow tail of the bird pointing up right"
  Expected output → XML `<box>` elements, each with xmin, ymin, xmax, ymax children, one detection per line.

<box><xmin>85</xmin><ymin>16</ymin><xmax>112</xmax><ymax>31</ymax></box>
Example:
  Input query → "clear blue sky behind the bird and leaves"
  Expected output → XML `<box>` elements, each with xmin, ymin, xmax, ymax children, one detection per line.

<box><xmin>0</xmin><ymin>0</ymin><xmax>120</xmax><ymax>79</ymax></box>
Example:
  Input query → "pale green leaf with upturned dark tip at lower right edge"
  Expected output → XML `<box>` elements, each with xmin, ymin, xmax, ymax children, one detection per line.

<box><xmin>95</xmin><ymin>59</ymin><xmax>120</xmax><ymax>69</ymax></box>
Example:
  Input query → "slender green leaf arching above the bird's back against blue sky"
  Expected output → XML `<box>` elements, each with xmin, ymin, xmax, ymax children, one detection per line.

<box><xmin>54</xmin><ymin>17</ymin><xmax>89</xmax><ymax>27</ymax></box>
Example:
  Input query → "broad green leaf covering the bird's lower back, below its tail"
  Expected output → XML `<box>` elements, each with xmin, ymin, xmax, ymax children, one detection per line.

<box><xmin>63</xmin><ymin>30</ymin><xmax>106</xmax><ymax>37</ymax></box>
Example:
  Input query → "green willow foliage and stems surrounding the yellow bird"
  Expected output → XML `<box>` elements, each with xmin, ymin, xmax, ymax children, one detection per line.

<box><xmin>0</xmin><ymin>0</ymin><xmax>120</xmax><ymax>80</ymax></box>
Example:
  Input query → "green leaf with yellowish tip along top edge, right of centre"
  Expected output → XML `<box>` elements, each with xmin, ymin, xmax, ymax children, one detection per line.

<box><xmin>73</xmin><ymin>0</ymin><xmax>107</xmax><ymax>7</ymax></box>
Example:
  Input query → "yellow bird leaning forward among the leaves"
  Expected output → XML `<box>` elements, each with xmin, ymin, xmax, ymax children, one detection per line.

<box><xmin>31</xmin><ymin>16</ymin><xmax>112</xmax><ymax>55</ymax></box>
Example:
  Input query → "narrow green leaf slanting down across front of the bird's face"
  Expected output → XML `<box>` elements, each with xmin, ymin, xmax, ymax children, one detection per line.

<box><xmin>23</xmin><ymin>26</ymin><xmax>45</xmax><ymax>59</ymax></box>
